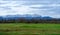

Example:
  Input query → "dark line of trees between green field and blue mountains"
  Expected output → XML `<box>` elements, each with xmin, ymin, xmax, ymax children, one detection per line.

<box><xmin>0</xmin><ymin>17</ymin><xmax>60</xmax><ymax>23</ymax></box>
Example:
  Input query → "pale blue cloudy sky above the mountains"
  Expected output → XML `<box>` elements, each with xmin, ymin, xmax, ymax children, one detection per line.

<box><xmin>0</xmin><ymin>0</ymin><xmax>60</xmax><ymax>18</ymax></box>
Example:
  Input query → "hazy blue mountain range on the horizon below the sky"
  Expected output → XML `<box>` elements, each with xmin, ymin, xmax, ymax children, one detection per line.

<box><xmin>0</xmin><ymin>14</ymin><xmax>52</xmax><ymax>20</ymax></box>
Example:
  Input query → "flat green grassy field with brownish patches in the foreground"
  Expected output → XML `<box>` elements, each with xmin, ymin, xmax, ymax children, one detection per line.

<box><xmin>0</xmin><ymin>23</ymin><xmax>60</xmax><ymax>35</ymax></box>
